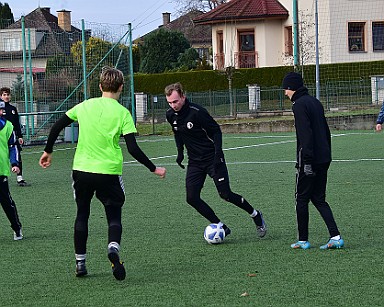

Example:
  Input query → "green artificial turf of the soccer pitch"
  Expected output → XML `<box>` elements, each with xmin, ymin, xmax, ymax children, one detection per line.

<box><xmin>0</xmin><ymin>131</ymin><xmax>384</xmax><ymax>306</ymax></box>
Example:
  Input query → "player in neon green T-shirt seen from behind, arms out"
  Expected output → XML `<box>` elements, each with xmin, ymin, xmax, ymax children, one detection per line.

<box><xmin>39</xmin><ymin>67</ymin><xmax>166</xmax><ymax>280</ymax></box>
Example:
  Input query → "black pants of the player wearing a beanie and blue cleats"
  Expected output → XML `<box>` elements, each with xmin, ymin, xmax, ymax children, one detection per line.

<box><xmin>295</xmin><ymin>163</ymin><xmax>340</xmax><ymax>241</ymax></box>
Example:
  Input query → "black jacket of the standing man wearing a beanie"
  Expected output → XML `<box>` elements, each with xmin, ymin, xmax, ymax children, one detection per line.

<box><xmin>291</xmin><ymin>86</ymin><xmax>332</xmax><ymax>167</ymax></box>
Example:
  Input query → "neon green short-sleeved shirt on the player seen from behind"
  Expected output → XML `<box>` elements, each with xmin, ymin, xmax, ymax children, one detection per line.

<box><xmin>65</xmin><ymin>97</ymin><xmax>136</xmax><ymax>175</ymax></box>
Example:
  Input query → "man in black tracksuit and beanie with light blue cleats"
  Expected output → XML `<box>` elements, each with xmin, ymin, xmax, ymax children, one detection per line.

<box><xmin>283</xmin><ymin>72</ymin><xmax>344</xmax><ymax>249</ymax></box>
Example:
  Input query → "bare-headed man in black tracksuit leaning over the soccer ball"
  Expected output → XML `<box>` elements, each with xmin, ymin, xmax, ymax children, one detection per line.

<box><xmin>165</xmin><ymin>83</ymin><xmax>267</xmax><ymax>237</ymax></box>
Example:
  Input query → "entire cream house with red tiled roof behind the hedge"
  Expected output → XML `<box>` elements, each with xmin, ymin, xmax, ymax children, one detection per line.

<box><xmin>193</xmin><ymin>0</ymin><xmax>384</xmax><ymax>69</ymax></box>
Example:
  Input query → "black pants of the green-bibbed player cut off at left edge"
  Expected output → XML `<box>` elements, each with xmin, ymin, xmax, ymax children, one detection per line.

<box><xmin>0</xmin><ymin>176</ymin><xmax>21</xmax><ymax>232</ymax></box>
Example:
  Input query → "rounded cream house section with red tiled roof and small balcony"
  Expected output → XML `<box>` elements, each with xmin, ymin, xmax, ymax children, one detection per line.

<box><xmin>193</xmin><ymin>0</ymin><xmax>289</xmax><ymax>69</ymax></box>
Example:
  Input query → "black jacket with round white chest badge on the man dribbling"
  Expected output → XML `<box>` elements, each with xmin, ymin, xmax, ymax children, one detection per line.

<box><xmin>166</xmin><ymin>99</ymin><xmax>222</xmax><ymax>161</ymax></box>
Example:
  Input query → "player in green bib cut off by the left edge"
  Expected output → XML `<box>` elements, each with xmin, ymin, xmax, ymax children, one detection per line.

<box><xmin>0</xmin><ymin>100</ymin><xmax>23</xmax><ymax>240</ymax></box>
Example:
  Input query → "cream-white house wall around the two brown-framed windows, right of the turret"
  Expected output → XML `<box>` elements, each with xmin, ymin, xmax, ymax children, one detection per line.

<box><xmin>279</xmin><ymin>0</ymin><xmax>384</xmax><ymax>64</ymax></box>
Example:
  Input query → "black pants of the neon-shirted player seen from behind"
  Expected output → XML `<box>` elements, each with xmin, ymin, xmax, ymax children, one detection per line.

<box><xmin>72</xmin><ymin>170</ymin><xmax>125</xmax><ymax>254</ymax></box>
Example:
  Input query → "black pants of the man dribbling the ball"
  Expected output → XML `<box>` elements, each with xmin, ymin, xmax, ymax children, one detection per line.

<box><xmin>185</xmin><ymin>161</ymin><xmax>254</xmax><ymax>224</ymax></box>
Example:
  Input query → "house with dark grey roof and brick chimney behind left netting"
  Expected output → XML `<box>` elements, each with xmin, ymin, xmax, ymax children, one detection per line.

<box><xmin>0</xmin><ymin>7</ymin><xmax>85</xmax><ymax>87</ymax></box>
